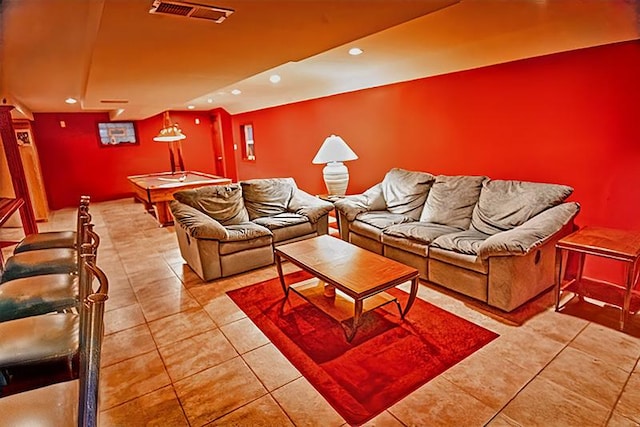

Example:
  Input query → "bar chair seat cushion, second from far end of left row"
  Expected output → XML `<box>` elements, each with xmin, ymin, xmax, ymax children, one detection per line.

<box><xmin>0</xmin><ymin>248</ymin><xmax>78</xmax><ymax>283</ymax></box>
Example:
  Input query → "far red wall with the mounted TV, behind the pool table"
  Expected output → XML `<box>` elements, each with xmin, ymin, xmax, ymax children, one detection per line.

<box><xmin>32</xmin><ymin>112</ymin><xmax>216</xmax><ymax>209</ymax></box>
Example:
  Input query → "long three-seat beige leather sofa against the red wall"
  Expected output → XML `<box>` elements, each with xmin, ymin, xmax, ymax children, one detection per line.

<box><xmin>335</xmin><ymin>169</ymin><xmax>580</xmax><ymax>311</ymax></box>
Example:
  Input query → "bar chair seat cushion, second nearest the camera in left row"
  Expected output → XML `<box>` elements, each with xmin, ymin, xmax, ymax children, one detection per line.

<box><xmin>0</xmin><ymin>313</ymin><xmax>79</xmax><ymax>368</ymax></box>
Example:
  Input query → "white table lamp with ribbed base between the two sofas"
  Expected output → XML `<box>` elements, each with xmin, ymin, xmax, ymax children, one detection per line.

<box><xmin>312</xmin><ymin>135</ymin><xmax>358</xmax><ymax>196</ymax></box>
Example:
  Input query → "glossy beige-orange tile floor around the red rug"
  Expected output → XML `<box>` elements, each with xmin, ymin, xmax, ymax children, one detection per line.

<box><xmin>0</xmin><ymin>200</ymin><xmax>640</xmax><ymax>426</ymax></box>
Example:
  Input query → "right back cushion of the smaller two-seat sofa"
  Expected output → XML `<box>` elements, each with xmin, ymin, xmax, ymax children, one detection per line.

<box><xmin>240</xmin><ymin>178</ymin><xmax>297</xmax><ymax>220</ymax></box>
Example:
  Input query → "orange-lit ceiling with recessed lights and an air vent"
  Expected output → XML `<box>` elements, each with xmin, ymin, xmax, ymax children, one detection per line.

<box><xmin>0</xmin><ymin>0</ymin><xmax>640</xmax><ymax>120</ymax></box>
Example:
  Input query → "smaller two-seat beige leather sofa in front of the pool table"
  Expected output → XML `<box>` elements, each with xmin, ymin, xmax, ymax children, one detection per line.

<box><xmin>170</xmin><ymin>178</ymin><xmax>333</xmax><ymax>281</ymax></box>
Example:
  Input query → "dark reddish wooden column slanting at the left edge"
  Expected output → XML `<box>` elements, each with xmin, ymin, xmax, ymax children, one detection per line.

<box><xmin>0</xmin><ymin>105</ymin><xmax>38</xmax><ymax>235</ymax></box>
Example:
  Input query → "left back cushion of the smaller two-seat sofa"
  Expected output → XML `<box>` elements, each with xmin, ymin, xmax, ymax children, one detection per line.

<box><xmin>173</xmin><ymin>184</ymin><xmax>249</xmax><ymax>225</ymax></box>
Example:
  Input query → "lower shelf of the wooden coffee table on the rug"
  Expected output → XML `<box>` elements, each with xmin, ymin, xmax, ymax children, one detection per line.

<box><xmin>287</xmin><ymin>277</ymin><xmax>404</xmax><ymax>342</ymax></box>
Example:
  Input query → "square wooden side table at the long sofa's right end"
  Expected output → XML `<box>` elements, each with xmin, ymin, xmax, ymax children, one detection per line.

<box><xmin>556</xmin><ymin>226</ymin><xmax>640</xmax><ymax>329</ymax></box>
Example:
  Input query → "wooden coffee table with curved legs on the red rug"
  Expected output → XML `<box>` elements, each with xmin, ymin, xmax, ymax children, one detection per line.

<box><xmin>275</xmin><ymin>235</ymin><xmax>419</xmax><ymax>341</ymax></box>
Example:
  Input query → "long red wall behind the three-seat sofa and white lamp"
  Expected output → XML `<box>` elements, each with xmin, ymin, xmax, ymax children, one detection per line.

<box><xmin>233</xmin><ymin>41</ymin><xmax>640</xmax><ymax>234</ymax></box>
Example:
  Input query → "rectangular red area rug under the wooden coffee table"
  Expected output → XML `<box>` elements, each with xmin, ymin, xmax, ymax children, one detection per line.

<box><xmin>228</xmin><ymin>272</ymin><xmax>498</xmax><ymax>425</ymax></box>
